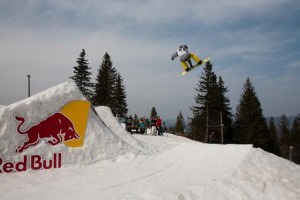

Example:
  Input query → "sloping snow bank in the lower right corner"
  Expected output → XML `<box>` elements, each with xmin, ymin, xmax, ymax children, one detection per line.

<box><xmin>218</xmin><ymin>148</ymin><xmax>300</xmax><ymax>200</ymax></box>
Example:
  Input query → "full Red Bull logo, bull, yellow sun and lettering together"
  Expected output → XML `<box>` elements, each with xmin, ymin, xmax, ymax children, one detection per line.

<box><xmin>0</xmin><ymin>100</ymin><xmax>90</xmax><ymax>173</ymax></box>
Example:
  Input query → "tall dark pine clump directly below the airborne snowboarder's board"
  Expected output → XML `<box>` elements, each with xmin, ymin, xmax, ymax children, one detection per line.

<box><xmin>190</xmin><ymin>62</ymin><xmax>232</xmax><ymax>142</ymax></box>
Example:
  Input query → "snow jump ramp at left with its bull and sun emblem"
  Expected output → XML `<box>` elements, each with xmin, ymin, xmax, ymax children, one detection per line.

<box><xmin>0</xmin><ymin>81</ymin><xmax>146</xmax><ymax>172</ymax></box>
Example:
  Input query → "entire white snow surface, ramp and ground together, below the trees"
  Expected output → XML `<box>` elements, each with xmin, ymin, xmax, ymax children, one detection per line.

<box><xmin>0</xmin><ymin>81</ymin><xmax>300</xmax><ymax>200</ymax></box>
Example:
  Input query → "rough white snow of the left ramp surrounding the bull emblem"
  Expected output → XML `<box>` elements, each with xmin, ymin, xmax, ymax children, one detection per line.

<box><xmin>0</xmin><ymin>81</ymin><xmax>142</xmax><ymax>165</ymax></box>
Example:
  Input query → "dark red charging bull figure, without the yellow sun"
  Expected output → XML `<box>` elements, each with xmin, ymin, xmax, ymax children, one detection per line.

<box><xmin>15</xmin><ymin>113</ymin><xmax>80</xmax><ymax>153</ymax></box>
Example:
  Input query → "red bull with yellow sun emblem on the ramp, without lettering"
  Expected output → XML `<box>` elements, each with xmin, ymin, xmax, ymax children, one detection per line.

<box><xmin>15</xmin><ymin>100</ymin><xmax>90</xmax><ymax>153</ymax></box>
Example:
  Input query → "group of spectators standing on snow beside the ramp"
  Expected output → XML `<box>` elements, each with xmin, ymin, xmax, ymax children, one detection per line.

<box><xmin>125</xmin><ymin>115</ymin><xmax>164</xmax><ymax>136</ymax></box>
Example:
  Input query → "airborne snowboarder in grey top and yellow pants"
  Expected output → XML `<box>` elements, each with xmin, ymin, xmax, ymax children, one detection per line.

<box><xmin>171</xmin><ymin>44</ymin><xmax>202</xmax><ymax>72</ymax></box>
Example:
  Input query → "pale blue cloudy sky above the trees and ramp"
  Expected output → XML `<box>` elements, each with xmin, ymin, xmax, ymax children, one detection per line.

<box><xmin>0</xmin><ymin>0</ymin><xmax>300</xmax><ymax>119</ymax></box>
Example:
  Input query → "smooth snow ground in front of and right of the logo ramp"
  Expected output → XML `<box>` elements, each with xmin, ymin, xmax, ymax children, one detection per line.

<box><xmin>0</xmin><ymin>135</ymin><xmax>300</xmax><ymax>200</ymax></box>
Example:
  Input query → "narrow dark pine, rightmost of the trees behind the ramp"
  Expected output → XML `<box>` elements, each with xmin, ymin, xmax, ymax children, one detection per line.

<box><xmin>112</xmin><ymin>73</ymin><xmax>128</xmax><ymax>117</ymax></box>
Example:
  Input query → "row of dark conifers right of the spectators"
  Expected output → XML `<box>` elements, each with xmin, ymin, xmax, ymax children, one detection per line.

<box><xmin>175</xmin><ymin>62</ymin><xmax>300</xmax><ymax>164</ymax></box>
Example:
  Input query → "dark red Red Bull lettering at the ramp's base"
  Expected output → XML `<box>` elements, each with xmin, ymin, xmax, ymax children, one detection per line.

<box><xmin>0</xmin><ymin>153</ymin><xmax>62</xmax><ymax>174</ymax></box>
